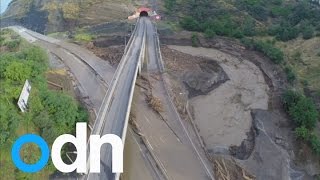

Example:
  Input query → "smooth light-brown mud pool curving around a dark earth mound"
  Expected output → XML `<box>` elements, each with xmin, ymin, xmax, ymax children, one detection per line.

<box><xmin>169</xmin><ymin>46</ymin><xmax>269</xmax><ymax>149</ymax></box>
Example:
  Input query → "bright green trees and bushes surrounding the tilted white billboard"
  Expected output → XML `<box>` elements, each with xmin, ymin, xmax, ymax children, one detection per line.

<box><xmin>0</xmin><ymin>30</ymin><xmax>88</xmax><ymax>179</ymax></box>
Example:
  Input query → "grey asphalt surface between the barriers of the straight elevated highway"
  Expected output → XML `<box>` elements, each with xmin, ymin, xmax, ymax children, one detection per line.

<box><xmin>87</xmin><ymin>18</ymin><xmax>148</xmax><ymax>180</ymax></box>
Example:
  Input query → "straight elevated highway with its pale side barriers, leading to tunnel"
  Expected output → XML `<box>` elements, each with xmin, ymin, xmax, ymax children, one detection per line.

<box><xmin>86</xmin><ymin>18</ymin><xmax>147</xmax><ymax>180</ymax></box>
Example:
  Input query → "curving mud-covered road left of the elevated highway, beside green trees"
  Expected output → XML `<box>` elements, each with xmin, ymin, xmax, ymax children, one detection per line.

<box><xmin>10</xmin><ymin>26</ymin><xmax>115</xmax><ymax>110</ymax></box>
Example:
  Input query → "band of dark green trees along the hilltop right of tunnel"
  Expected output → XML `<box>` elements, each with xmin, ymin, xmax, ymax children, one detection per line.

<box><xmin>175</xmin><ymin>0</ymin><xmax>320</xmax><ymax>41</ymax></box>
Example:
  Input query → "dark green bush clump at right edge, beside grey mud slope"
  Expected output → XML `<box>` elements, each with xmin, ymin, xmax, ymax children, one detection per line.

<box><xmin>282</xmin><ymin>90</ymin><xmax>320</xmax><ymax>155</ymax></box>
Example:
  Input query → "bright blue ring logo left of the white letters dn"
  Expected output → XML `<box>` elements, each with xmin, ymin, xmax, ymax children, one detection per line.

<box><xmin>11</xmin><ymin>134</ymin><xmax>50</xmax><ymax>173</ymax></box>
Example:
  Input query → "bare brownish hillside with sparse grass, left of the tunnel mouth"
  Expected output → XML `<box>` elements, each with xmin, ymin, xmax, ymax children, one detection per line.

<box><xmin>1</xmin><ymin>0</ymin><xmax>142</xmax><ymax>33</ymax></box>
